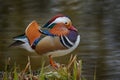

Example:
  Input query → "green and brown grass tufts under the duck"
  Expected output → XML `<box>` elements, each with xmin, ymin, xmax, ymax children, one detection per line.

<box><xmin>3</xmin><ymin>56</ymin><xmax>85</xmax><ymax>80</ymax></box>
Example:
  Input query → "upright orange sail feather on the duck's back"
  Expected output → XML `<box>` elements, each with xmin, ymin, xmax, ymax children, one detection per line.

<box><xmin>25</xmin><ymin>21</ymin><xmax>41</xmax><ymax>45</ymax></box>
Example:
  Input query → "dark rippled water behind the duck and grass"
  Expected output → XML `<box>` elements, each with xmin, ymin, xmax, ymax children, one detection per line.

<box><xmin>0</xmin><ymin>0</ymin><xmax>120</xmax><ymax>80</ymax></box>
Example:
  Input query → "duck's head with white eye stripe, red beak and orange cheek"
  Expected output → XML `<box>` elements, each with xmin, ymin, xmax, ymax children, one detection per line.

<box><xmin>43</xmin><ymin>14</ymin><xmax>77</xmax><ymax>35</ymax></box>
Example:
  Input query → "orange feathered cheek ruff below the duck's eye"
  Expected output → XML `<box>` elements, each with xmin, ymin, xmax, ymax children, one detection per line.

<box><xmin>50</xmin><ymin>23</ymin><xmax>69</xmax><ymax>36</ymax></box>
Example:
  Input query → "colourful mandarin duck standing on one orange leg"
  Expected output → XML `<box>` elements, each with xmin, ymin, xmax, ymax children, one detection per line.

<box><xmin>10</xmin><ymin>14</ymin><xmax>80</xmax><ymax>67</ymax></box>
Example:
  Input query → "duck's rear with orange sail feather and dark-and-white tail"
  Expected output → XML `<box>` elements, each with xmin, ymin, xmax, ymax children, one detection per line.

<box><xmin>9</xmin><ymin>21</ymin><xmax>41</xmax><ymax>52</ymax></box>
